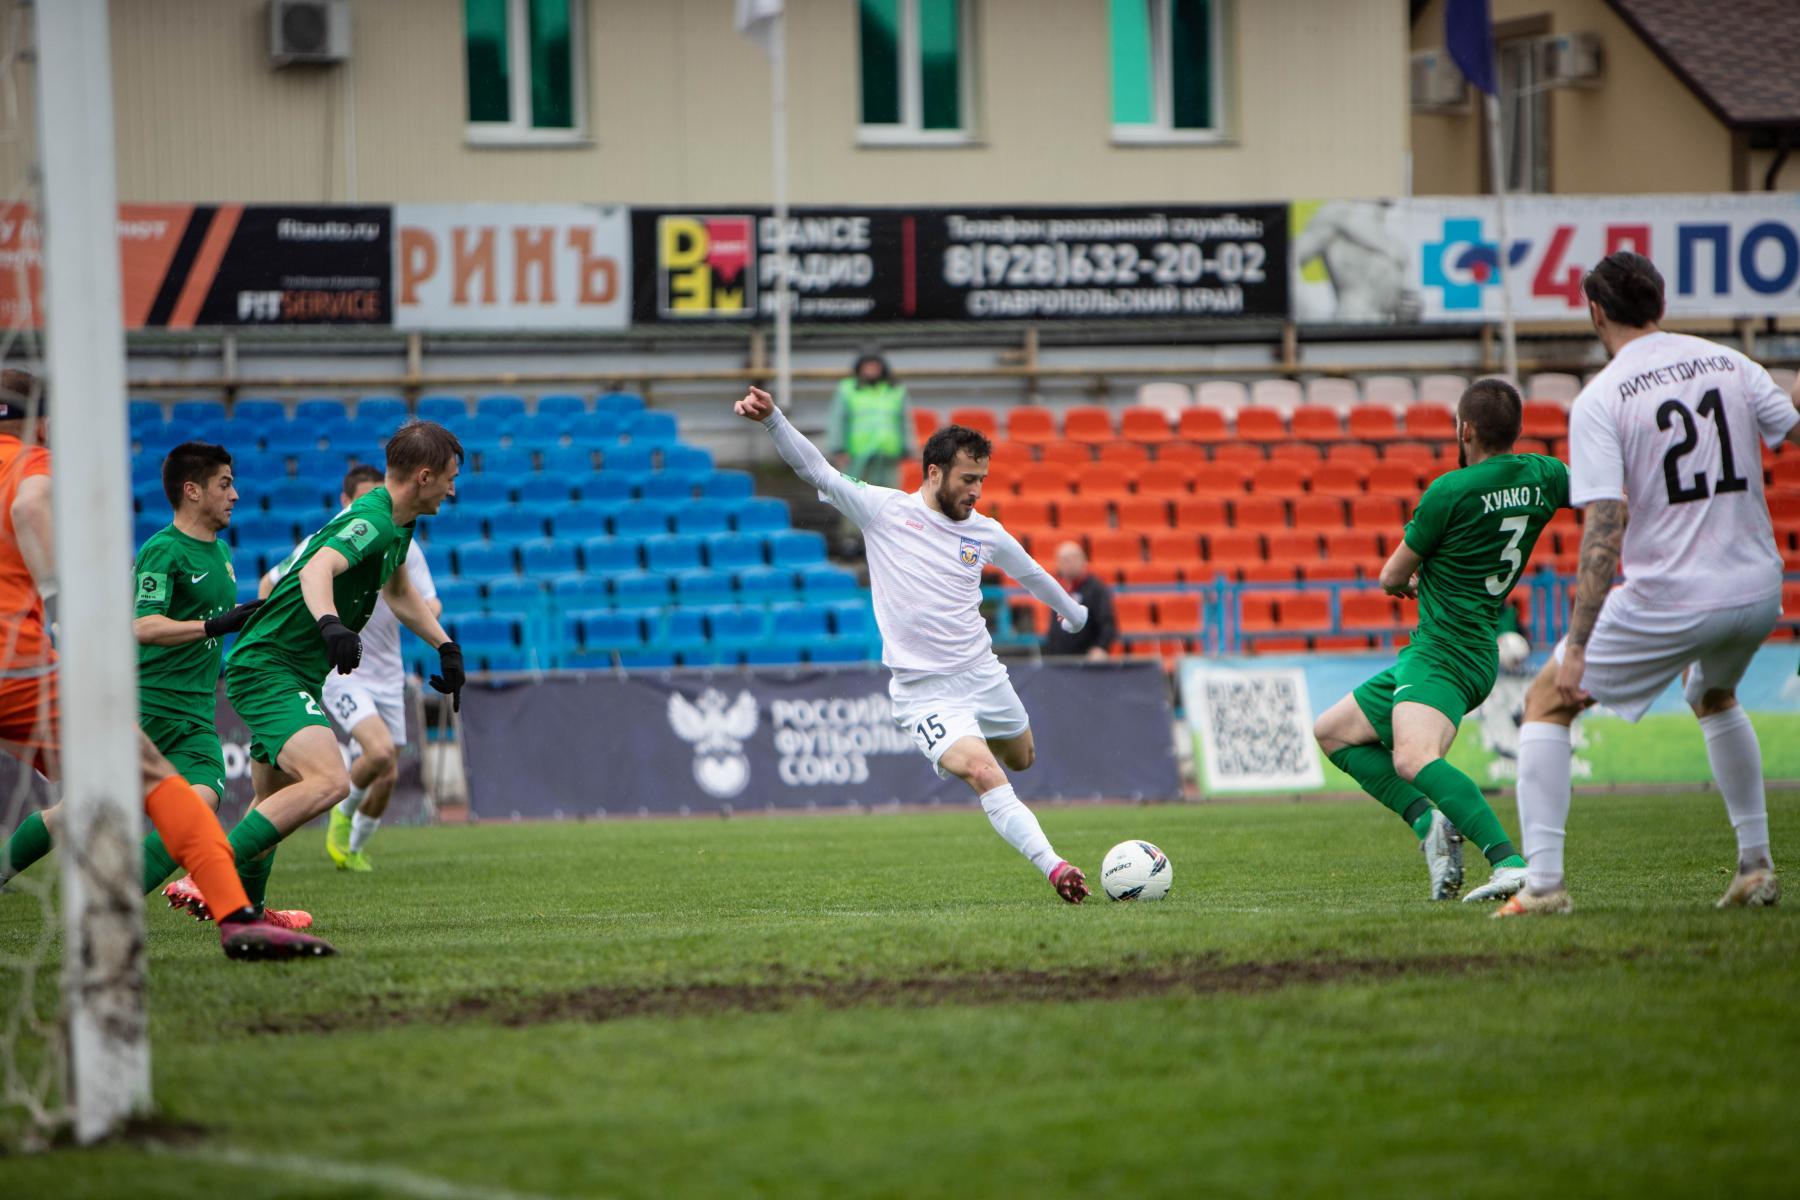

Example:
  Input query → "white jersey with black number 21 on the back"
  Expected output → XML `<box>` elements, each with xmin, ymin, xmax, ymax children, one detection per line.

<box><xmin>1570</xmin><ymin>333</ymin><xmax>1800</xmax><ymax>610</ymax></box>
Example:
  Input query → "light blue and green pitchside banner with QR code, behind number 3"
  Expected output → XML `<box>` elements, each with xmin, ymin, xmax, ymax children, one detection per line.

<box><xmin>1181</xmin><ymin>642</ymin><xmax>1800</xmax><ymax>792</ymax></box>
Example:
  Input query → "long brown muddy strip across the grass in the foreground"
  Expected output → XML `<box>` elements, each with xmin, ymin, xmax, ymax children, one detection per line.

<box><xmin>248</xmin><ymin>955</ymin><xmax>1503</xmax><ymax>1033</ymax></box>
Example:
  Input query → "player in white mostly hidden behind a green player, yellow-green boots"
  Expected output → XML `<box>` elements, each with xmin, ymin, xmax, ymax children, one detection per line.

<box><xmin>257</xmin><ymin>464</ymin><xmax>443</xmax><ymax>871</ymax></box>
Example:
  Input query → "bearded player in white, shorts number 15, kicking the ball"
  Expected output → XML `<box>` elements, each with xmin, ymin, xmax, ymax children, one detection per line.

<box><xmin>736</xmin><ymin>387</ymin><xmax>1087</xmax><ymax>905</ymax></box>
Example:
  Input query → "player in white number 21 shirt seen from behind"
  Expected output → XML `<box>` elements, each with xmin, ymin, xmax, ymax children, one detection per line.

<box><xmin>1494</xmin><ymin>250</ymin><xmax>1800</xmax><ymax>918</ymax></box>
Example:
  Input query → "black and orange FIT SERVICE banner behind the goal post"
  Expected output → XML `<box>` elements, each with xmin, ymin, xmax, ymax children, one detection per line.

<box><xmin>0</xmin><ymin>205</ymin><xmax>391</xmax><ymax>329</ymax></box>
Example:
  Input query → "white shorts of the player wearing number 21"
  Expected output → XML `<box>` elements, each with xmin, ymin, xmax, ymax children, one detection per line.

<box><xmin>1557</xmin><ymin>588</ymin><xmax>1782</xmax><ymax>721</ymax></box>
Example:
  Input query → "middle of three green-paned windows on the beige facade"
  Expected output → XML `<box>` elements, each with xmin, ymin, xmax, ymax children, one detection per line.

<box><xmin>859</xmin><ymin>0</ymin><xmax>974</xmax><ymax>144</ymax></box>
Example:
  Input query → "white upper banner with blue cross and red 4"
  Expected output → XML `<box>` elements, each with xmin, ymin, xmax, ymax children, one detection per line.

<box><xmin>1291</xmin><ymin>193</ymin><xmax>1800</xmax><ymax>324</ymax></box>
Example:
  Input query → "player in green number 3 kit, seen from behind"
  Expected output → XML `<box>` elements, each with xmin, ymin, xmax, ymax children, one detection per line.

<box><xmin>1312</xmin><ymin>380</ymin><xmax>1570</xmax><ymax>901</ymax></box>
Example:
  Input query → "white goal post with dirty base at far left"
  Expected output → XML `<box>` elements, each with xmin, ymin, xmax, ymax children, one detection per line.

<box><xmin>32</xmin><ymin>0</ymin><xmax>149</xmax><ymax>1142</ymax></box>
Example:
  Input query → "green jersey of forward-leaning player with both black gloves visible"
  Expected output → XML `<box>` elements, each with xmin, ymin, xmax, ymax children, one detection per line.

<box><xmin>230</xmin><ymin>488</ymin><xmax>412</xmax><ymax>687</ymax></box>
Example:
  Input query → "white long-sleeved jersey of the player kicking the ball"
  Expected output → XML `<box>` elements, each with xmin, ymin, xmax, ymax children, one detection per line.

<box><xmin>763</xmin><ymin>410</ymin><xmax>1080</xmax><ymax>676</ymax></box>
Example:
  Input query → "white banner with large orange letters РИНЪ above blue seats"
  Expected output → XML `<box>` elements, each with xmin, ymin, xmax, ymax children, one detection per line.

<box><xmin>394</xmin><ymin>203</ymin><xmax>632</xmax><ymax>329</ymax></box>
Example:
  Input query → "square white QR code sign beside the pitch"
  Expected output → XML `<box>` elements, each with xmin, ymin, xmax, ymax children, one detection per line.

<box><xmin>1188</xmin><ymin>667</ymin><xmax>1325</xmax><ymax>792</ymax></box>
